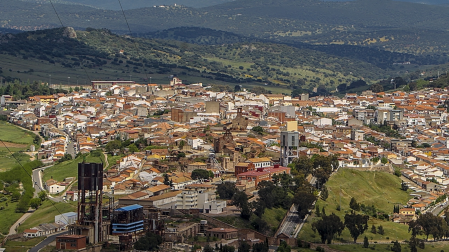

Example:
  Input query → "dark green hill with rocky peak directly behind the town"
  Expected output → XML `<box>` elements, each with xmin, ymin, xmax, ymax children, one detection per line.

<box><xmin>0</xmin><ymin>26</ymin><xmax>400</xmax><ymax>93</ymax></box>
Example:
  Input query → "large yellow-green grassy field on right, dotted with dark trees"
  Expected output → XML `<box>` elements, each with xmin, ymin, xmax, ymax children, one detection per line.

<box><xmin>299</xmin><ymin>169</ymin><xmax>411</xmax><ymax>242</ymax></box>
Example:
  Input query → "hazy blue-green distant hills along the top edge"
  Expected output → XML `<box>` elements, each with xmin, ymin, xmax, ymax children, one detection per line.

<box><xmin>4</xmin><ymin>0</ymin><xmax>449</xmax><ymax>55</ymax></box>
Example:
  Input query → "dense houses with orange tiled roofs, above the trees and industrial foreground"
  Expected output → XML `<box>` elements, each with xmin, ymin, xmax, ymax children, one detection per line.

<box><xmin>6</xmin><ymin>77</ymin><xmax>449</xmax><ymax>236</ymax></box>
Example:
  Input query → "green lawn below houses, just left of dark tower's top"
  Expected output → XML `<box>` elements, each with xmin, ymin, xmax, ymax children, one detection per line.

<box><xmin>42</xmin><ymin>154</ymin><xmax>104</xmax><ymax>183</ymax></box>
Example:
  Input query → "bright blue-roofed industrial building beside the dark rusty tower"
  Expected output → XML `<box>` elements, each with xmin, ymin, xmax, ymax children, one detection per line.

<box><xmin>112</xmin><ymin>204</ymin><xmax>143</xmax><ymax>234</ymax></box>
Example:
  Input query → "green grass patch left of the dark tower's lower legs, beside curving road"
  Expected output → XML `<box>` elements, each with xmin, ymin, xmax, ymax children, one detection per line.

<box><xmin>19</xmin><ymin>200</ymin><xmax>77</xmax><ymax>232</ymax></box>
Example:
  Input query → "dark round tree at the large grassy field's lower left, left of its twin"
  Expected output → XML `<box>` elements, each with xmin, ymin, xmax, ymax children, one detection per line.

<box><xmin>312</xmin><ymin>213</ymin><xmax>345</xmax><ymax>244</ymax></box>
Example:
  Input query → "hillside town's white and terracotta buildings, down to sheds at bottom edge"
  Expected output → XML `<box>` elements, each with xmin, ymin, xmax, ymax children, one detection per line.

<box><xmin>1</xmin><ymin>77</ymin><xmax>449</xmax><ymax>250</ymax></box>
